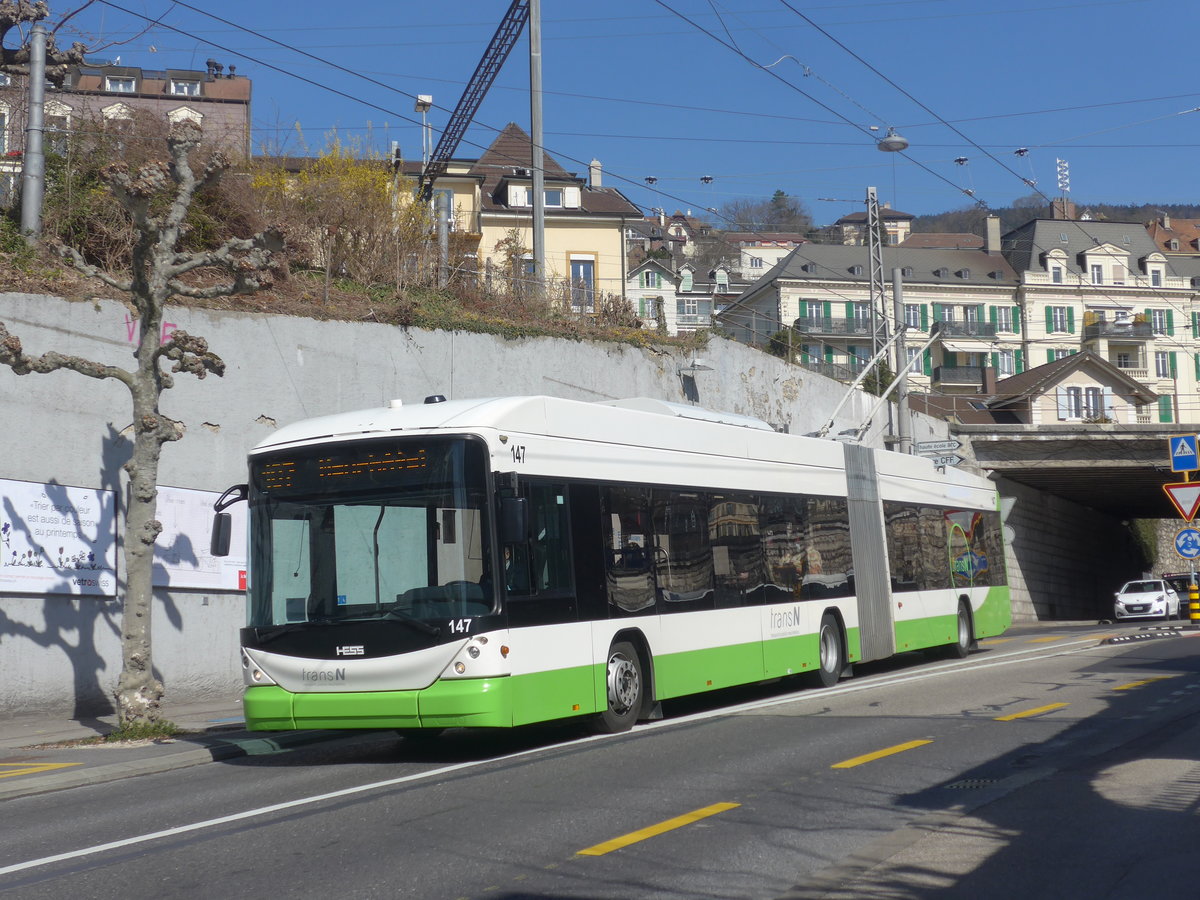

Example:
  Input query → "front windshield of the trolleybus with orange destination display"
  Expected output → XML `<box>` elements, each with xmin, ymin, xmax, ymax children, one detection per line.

<box><xmin>250</xmin><ymin>438</ymin><xmax>496</xmax><ymax>629</ymax></box>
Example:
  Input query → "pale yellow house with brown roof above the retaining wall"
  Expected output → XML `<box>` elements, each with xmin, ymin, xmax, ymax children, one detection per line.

<box><xmin>406</xmin><ymin>122</ymin><xmax>642</xmax><ymax>312</ymax></box>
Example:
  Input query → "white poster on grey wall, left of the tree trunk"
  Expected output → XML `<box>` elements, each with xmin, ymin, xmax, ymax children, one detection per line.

<box><xmin>0</xmin><ymin>479</ymin><xmax>116</xmax><ymax>596</ymax></box>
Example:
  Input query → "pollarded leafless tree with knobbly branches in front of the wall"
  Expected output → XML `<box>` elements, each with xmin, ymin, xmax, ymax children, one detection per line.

<box><xmin>0</xmin><ymin>122</ymin><xmax>282</xmax><ymax>727</ymax></box>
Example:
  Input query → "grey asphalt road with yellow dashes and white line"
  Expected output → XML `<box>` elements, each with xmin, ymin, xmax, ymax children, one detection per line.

<box><xmin>0</xmin><ymin>628</ymin><xmax>1200</xmax><ymax>900</ymax></box>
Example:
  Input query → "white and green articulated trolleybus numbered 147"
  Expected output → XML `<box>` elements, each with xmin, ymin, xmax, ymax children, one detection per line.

<box><xmin>214</xmin><ymin>397</ymin><xmax>1010</xmax><ymax>732</ymax></box>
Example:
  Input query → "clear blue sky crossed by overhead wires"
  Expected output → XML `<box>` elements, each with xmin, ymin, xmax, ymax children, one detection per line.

<box><xmin>53</xmin><ymin>0</ymin><xmax>1200</xmax><ymax>224</ymax></box>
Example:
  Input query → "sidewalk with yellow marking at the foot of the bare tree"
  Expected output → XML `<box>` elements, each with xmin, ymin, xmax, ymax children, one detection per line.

<box><xmin>0</xmin><ymin>697</ymin><xmax>348</xmax><ymax>800</ymax></box>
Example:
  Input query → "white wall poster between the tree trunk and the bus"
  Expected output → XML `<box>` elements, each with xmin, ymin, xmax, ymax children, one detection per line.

<box><xmin>154</xmin><ymin>486</ymin><xmax>246</xmax><ymax>590</ymax></box>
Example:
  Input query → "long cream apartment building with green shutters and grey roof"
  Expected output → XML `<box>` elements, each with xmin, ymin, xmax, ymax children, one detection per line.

<box><xmin>718</xmin><ymin>217</ymin><xmax>1200</xmax><ymax>424</ymax></box>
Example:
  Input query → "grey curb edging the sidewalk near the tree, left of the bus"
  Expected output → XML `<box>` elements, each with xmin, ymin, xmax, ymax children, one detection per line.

<box><xmin>0</xmin><ymin>731</ymin><xmax>352</xmax><ymax>800</ymax></box>
